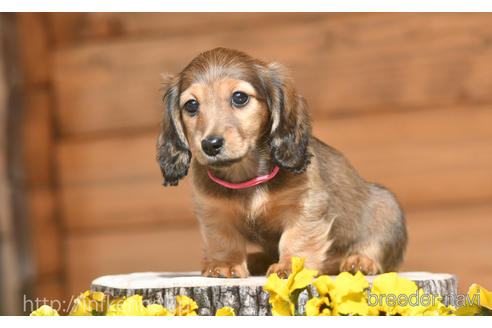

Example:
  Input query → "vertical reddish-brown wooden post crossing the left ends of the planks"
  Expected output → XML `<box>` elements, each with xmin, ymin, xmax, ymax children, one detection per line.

<box><xmin>15</xmin><ymin>13</ymin><xmax>62</xmax><ymax>308</ymax></box>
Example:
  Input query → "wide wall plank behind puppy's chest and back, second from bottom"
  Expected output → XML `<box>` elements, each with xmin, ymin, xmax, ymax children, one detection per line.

<box><xmin>58</xmin><ymin>106</ymin><xmax>492</xmax><ymax>229</ymax></box>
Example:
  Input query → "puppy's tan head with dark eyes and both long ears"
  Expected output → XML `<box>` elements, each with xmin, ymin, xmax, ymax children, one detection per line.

<box><xmin>157</xmin><ymin>48</ymin><xmax>311</xmax><ymax>186</ymax></box>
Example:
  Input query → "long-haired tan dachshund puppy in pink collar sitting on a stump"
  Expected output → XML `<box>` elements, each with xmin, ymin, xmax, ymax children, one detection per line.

<box><xmin>157</xmin><ymin>48</ymin><xmax>407</xmax><ymax>277</ymax></box>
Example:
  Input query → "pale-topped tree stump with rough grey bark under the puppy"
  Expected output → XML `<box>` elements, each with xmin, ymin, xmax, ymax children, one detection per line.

<box><xmin>91</xmin><ymin>272</ymin><xmax>458</xmax><ymax>316</ymax></box>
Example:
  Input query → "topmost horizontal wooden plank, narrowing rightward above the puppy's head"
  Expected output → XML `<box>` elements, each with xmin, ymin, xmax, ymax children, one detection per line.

<box><xmin>47</xmin><ymin>12</ymin><xmax>330</xmax><ymax>48</ymax></box>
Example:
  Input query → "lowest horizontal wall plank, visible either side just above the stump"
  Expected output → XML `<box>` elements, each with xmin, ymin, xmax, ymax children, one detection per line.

<box><xmin>66</xmin><ymin>205</ymin><xmax>492</xmax><ymax>295</ymax></box>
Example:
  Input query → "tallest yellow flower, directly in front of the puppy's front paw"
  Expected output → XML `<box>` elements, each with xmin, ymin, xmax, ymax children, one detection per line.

<box><xmin>263</xmin><ymin>257</ymin><xmax>318</xmax><ymax>316</ymax></box>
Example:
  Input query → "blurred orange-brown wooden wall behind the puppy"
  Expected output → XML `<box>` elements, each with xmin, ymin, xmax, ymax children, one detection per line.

<box><xmin>0</xmin><ymin>13</ymin><xmax>492</xmax><ymax>314</ymax></box>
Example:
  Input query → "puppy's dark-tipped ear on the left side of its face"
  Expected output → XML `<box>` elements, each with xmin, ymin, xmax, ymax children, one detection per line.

<box><xmin>157</xmin><ymin>76</ymin><xmax>191</xmax><ymax>186</ymax></box>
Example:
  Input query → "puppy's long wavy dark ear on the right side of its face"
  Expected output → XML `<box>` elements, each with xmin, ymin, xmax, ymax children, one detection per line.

<box><xmin>262</xmin><ymin>63</ymin><xmax>312</xmax><ymax>174</ymax></box>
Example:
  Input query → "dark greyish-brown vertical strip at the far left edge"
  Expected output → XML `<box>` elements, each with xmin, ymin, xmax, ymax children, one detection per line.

<box><xmin>0</xmin><ymin>13</ymin><xmax>36</xmax><ymax>315</ymax></box>
